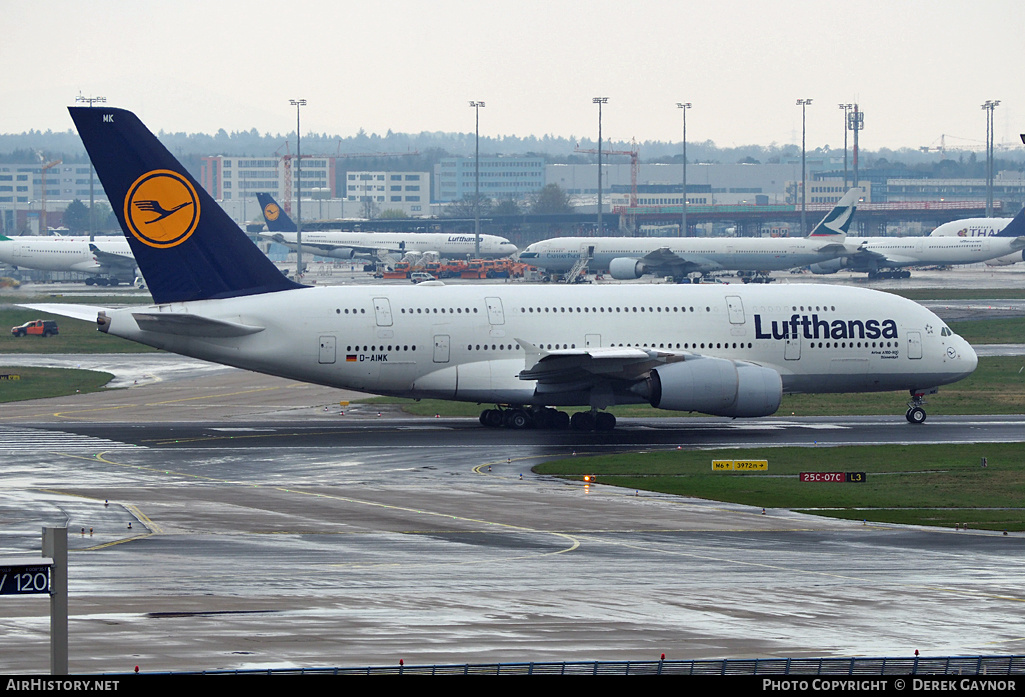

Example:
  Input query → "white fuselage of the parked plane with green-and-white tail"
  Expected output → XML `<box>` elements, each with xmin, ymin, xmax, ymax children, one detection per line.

<box><xmin>520</xmin><ymin>237</ymin><xmax>844</xmax><ymax>273</ymax></box>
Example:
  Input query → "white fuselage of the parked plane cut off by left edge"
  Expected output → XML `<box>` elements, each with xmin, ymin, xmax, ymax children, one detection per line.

<box><xmin>0</xmin><ymin>235</ymin><xmax>134</xmax><ymax>280</ymax></box>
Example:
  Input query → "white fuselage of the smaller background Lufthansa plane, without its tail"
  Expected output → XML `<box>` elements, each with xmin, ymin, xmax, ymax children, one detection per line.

<box><xmin>260</xmin><ymin>231</ymin><xmax>517</xmax><ymax>259</ymax></box>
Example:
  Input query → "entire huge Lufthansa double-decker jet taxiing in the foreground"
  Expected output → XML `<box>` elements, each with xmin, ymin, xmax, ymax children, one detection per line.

<box><xmin>24</xmin><ymin>107</ymin><xmax>977</xmax><ymax>431</ymax></box>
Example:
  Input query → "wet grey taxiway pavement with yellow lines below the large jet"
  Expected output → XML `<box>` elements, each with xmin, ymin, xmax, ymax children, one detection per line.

<box><xmin>0</xmin><ymin>367</ymin><xmax>1025</xmax><ymax>672</ymax></box>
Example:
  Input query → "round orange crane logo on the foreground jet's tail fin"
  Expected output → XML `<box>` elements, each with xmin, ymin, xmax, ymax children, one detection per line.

<box><xmin>124</xmin><ymin>169</ymin><xmax>200</xmax><ymax>248</ymax></box>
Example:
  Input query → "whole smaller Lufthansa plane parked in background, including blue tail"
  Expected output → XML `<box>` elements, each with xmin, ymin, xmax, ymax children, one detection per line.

<box><xmin>256</xmin><ymin>194</ymin><xmax>517</xmax><ymax>259</ymax></box>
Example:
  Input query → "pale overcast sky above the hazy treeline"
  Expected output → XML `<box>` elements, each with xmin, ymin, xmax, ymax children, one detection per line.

<box><xmin>0</xmin><ymin>0</ymin><xmax>1025</xmax><ymax>152</ymax></box>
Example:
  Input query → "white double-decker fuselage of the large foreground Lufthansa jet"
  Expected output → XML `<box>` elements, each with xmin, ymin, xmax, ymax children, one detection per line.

<box><xmin>101</xmin><ymin>284</ymin><xmax>977</xmax><ymax>405</ymax></box>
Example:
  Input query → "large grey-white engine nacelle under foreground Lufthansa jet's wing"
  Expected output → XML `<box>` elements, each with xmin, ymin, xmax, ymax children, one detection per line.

<box><xmin>646</xmin><ymin>357</ymin><xmax>783</xmax><ymax>416</ymax></box>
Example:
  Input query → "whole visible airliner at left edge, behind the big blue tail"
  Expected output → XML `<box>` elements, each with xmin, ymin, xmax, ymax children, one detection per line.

<box><xmin>0</xmin><ymin>235</ymin><xmax>138</xmax><ymax>286</ymax></box>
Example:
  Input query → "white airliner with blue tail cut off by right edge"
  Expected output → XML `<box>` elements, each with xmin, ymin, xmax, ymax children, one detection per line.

<box><xmin>812</xmin><ymin>203</ymin><xmax>1025</xmax><ymax>279</ymax></box>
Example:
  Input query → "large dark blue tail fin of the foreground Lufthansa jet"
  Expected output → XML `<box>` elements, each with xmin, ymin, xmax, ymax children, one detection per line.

<box><xmin>68</xmin><ymin>107</ymin><xmax>302</xmax><ymax>304</ymax></box>
